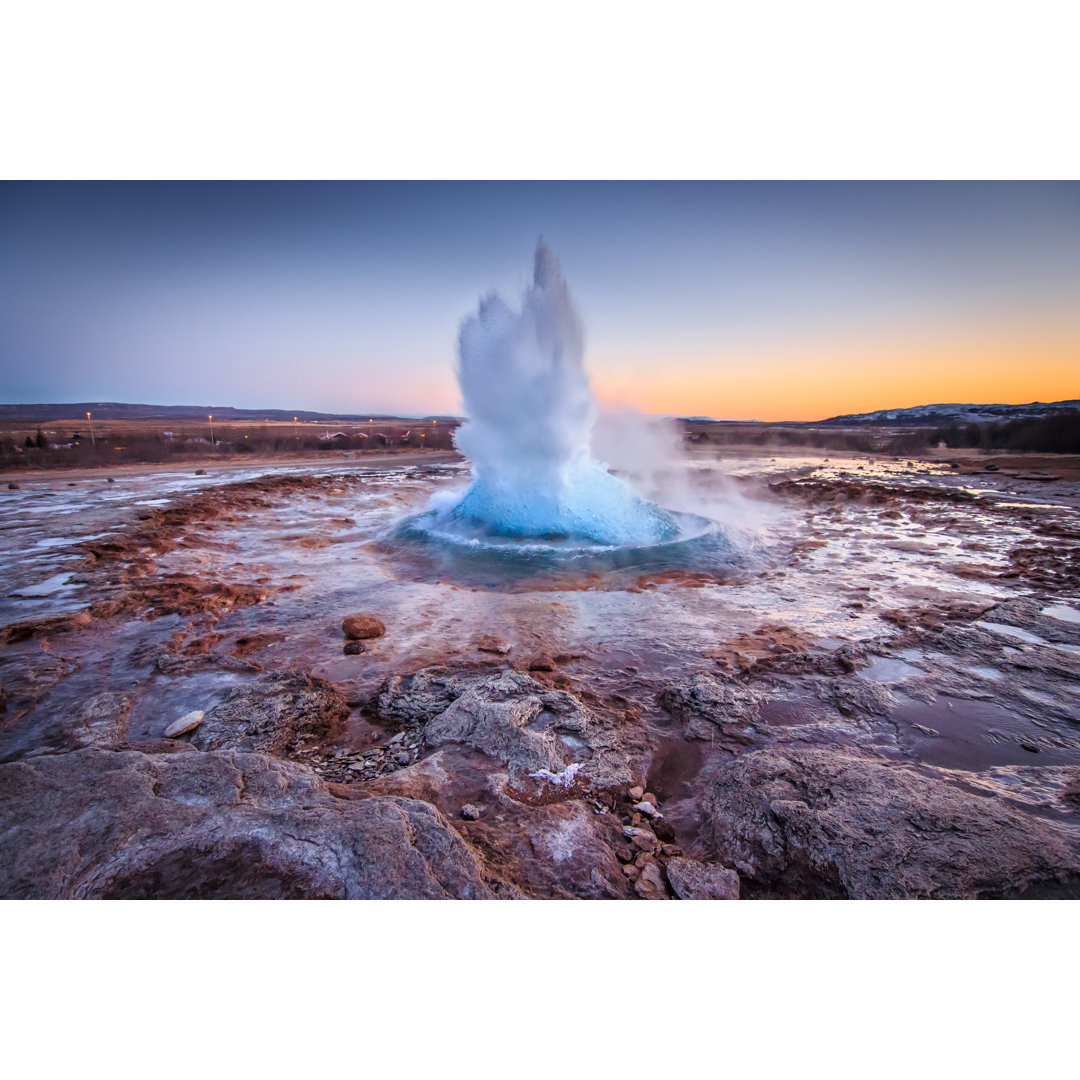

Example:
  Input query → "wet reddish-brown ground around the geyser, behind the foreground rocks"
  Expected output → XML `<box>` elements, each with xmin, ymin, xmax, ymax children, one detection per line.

<box><xmin>0</xmin><ymin>453</ymin><xmax>1080</xmax><ymax>894</ymax></box>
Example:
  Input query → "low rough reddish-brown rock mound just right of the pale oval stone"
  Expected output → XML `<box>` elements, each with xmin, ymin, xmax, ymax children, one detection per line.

<box><xmin>191</xmin><ymin>671</ymin><xmax>349</xmax><ymax>755</ymax></box>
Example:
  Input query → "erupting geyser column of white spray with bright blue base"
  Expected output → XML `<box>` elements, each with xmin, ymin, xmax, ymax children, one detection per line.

<box><xmin>440</xmin><ymin>243</ymin><xmax>679</xmax><ymax>546</ymax></box>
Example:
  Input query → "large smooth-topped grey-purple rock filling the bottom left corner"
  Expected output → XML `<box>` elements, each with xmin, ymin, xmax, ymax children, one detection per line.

<box><xmin>0</xmin><ymin>750</ymin><xmax>492</xmax><ymax>900</ymax></box>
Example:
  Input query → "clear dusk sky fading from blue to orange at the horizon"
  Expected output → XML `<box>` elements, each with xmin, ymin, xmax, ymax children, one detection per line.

<box><xmin>0</xmin><ymin>181</ymin><xmax>1080</xmax><ymax>420</ymax></box>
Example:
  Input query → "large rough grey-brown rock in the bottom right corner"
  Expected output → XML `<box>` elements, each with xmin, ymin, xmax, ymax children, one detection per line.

<box><xmin>704</xmin><ymin>747</ymin><xmax>1080</xmax><ymax>900</ymax></box>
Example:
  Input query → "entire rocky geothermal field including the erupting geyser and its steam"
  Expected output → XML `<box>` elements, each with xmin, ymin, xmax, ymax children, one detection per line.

<box><xmin>0</xmin><ymin>246</ymin><xmax>1080</xmax><ymax>900</ymax></box>
